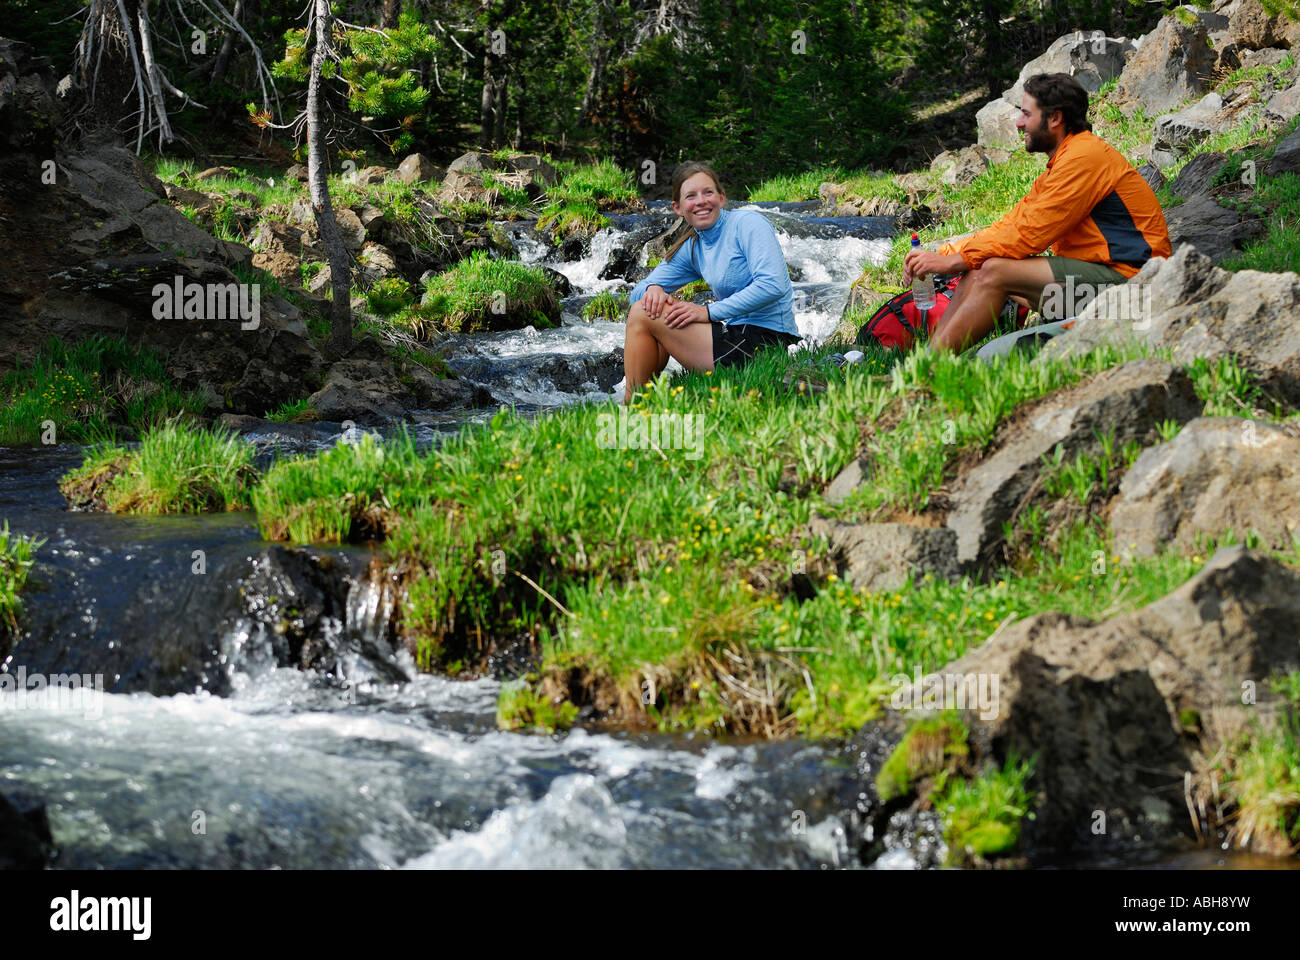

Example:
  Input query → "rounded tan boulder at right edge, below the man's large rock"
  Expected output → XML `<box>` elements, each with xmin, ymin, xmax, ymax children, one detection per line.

<box><xmin>1110</xmin><ymin>416</ymin><xmax>1300</xmax><ymax>555</ymax></box>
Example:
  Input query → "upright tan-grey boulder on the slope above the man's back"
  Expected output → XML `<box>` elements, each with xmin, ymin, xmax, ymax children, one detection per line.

<box><xmin>1113</xmin><ymin>16</ymin><xmax>1214</xmax><ymax>116</ymax></box>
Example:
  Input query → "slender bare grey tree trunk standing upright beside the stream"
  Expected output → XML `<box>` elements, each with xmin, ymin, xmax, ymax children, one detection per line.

<box><xmin>307</xmin><ymin>0</ymin><xmax>352</xmax><ymax>354</ymax></box>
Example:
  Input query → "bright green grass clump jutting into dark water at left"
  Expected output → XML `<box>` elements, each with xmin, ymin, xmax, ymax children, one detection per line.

<box><xmin>60</xmin><ymin>424</ymin><xmax>256</xmax><ymax>514</ymax></box>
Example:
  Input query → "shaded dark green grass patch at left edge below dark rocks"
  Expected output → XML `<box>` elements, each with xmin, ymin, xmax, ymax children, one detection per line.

<box><xmin>0</xmin><ymin>336</ymin><xmax>203</xmax><ymax>445</ymax></box>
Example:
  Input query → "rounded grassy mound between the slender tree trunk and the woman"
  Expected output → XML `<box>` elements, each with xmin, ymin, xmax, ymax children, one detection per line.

<box><xmin>420</xmin><ymin>251</ymin><xmax>556</xmax><ymax>333</ymax></box>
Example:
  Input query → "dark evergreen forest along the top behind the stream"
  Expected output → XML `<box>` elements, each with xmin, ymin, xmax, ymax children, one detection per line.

<box><xmin>0</xmin><ymin>0</ymin><xmax>1175</xmax><ymax>181</ymax></box>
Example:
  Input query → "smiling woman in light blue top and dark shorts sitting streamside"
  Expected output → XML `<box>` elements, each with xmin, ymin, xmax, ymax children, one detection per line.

<box><xmin>623</xmin><ymin>164</ymin><xmax>800</xmax><ymax>405</ymax></box>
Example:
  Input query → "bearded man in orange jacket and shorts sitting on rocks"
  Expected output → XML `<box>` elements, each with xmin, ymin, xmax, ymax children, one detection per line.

<box><xmin>902</xmin><ymin>73</ymin><xmax>1171</xmax><ymax>351</ymax></box>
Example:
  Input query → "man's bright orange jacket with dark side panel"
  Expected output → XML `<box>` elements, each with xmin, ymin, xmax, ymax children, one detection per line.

<box><xmin>939</xmin><ymin>130</ymin><xmax>1171</xmax><ymax>277</ymax></box>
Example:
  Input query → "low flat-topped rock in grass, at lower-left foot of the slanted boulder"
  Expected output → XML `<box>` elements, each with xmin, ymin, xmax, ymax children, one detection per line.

<box><xmin>809</xmin><ymin>514</ymin><xmax>961</xmax><ymax>592</ymax></box>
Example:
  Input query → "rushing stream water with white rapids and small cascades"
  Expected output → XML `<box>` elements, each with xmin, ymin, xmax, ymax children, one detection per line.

<box><xmin>0</xmin><ymin>204</ymin><xmax>1242</xmax><ymax>869</ymax></box>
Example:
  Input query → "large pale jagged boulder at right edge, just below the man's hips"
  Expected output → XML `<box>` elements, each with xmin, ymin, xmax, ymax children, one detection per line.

<box><xmin>1040</xmin><ymin>243</ymin><xmax>1300</xmax><ymax>406</ymax></box>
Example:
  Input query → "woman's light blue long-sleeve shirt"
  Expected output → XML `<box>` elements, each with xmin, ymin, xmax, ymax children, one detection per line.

<box><xmin>629</xmin><ymin>209</ymin><xmax>800</xmax><ymax>337</ymax></box>
